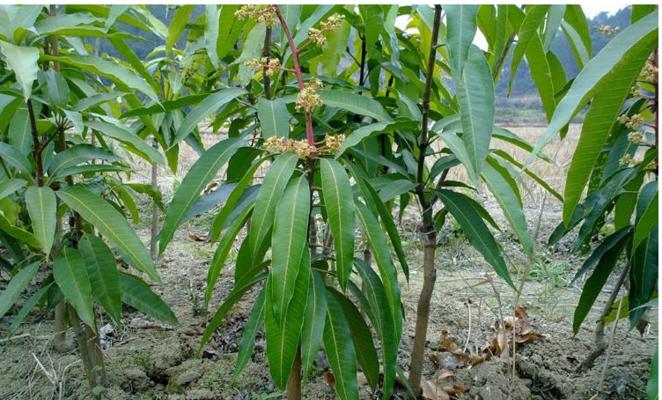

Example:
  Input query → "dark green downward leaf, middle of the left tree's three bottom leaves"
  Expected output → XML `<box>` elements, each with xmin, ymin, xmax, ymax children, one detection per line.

<box><xmin>78</xmin><ymin>234</ymin><xmax>122</xmax><ymax>324</ymax></box>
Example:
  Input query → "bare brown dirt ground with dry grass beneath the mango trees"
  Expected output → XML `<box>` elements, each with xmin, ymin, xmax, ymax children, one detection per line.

<box><xmin>0</xmin><ymin>127</ymin><xmax>658</xmax><ymax>400</ymax></box>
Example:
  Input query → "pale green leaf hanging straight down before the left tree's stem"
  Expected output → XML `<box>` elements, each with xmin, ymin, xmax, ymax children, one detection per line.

<box><xmin>25</xmin><ymin>186</ymin><xmax>57</xmax><ymax>255</ymax></box>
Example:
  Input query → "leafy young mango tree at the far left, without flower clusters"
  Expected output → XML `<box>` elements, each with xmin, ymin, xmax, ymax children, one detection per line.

<box><xmin>0</xmin><ymin>6</ymin><xmax>176</xmax><ymax>396</ymax></box>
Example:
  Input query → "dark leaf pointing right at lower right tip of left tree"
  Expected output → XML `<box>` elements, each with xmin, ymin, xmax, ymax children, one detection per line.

<box><xmin>119</xmin><ymin>272</ymin><xmax>177</xmax><ymax>325</ymax></box>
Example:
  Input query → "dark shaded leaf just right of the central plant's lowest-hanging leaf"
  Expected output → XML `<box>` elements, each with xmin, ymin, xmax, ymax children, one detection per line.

<box><xmin>327</xmin><ymin>288</ymin><xmax>379</xmax><ymax>391</ymax></box>
